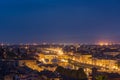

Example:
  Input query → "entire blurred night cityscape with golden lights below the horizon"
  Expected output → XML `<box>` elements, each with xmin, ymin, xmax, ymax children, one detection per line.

<box><xmin>0</xmin><ymin>43</ymin><xmax>120</xmax><ymax>80</ymax></box>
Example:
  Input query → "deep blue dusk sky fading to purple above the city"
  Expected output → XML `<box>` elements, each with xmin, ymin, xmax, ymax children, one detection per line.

<box><xmin>0</xmin><ymin>0</ymin><xmax>120</xmax><ymax>43</ymax></box>
